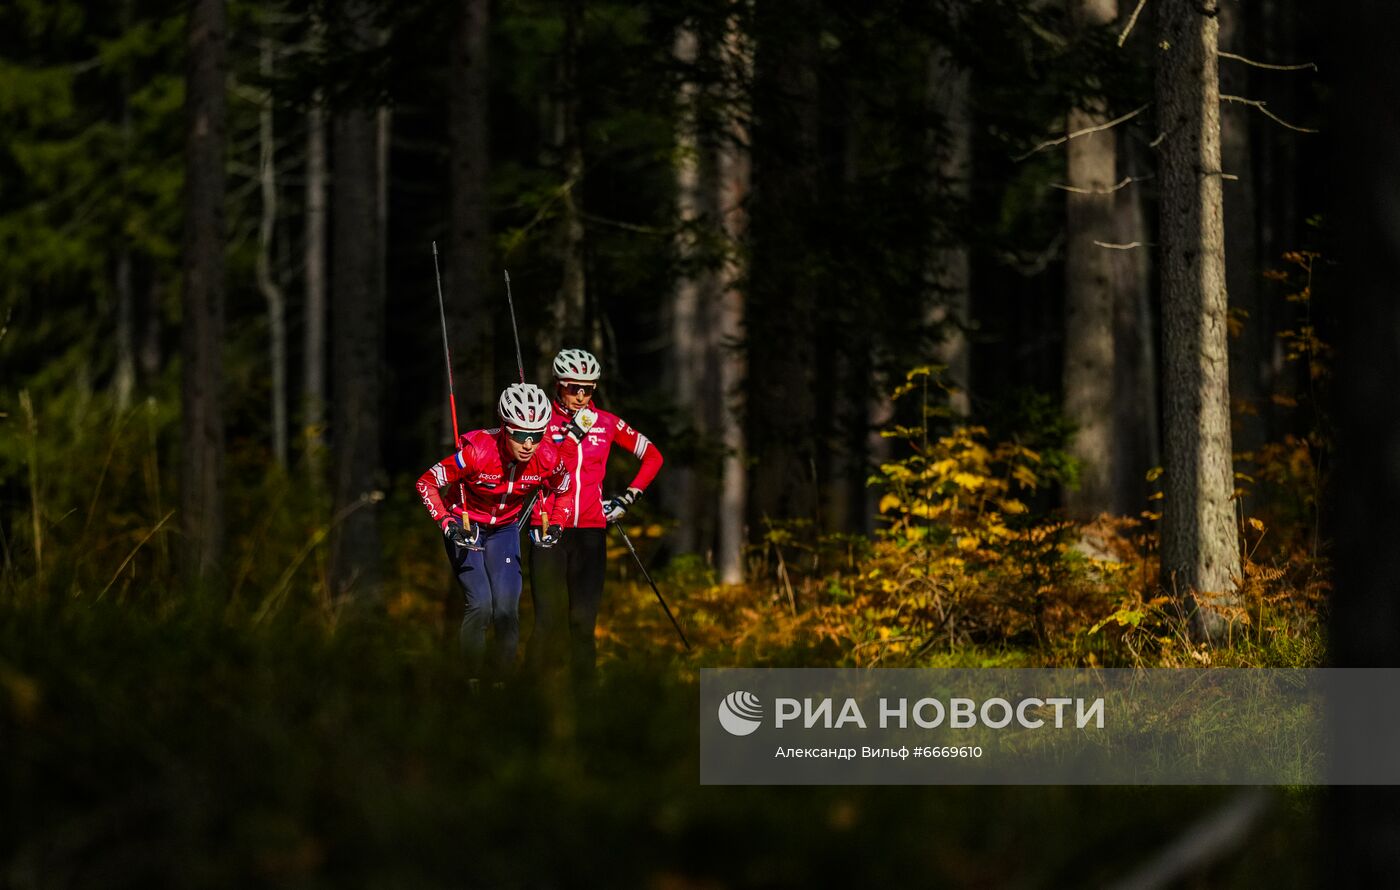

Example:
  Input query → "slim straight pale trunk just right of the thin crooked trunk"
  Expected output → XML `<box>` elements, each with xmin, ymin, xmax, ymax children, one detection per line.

<box><xmin>301</xmin><ymin>98</ymin><xmax>326</xmax><ymax>455</ymax></box>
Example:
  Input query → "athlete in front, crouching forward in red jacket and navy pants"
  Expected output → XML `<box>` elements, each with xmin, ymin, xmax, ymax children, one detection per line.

<box><xmin>417</xmin><ymin>383</ymin><xmax>571</xmax><ymax>676</ymax></box>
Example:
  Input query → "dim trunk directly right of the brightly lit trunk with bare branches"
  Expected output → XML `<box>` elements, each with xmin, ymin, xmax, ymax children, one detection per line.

<box><xmin>1221</xmin><ymin>1</ymin><xmax>1265</xmax><ymax>452</ymax></box>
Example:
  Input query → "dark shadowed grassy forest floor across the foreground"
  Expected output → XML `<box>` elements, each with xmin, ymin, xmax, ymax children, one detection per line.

<box><xmin>0</xmin><ymin>534</ymin><xmax>1320</xmax><ymax>889</ymax></box>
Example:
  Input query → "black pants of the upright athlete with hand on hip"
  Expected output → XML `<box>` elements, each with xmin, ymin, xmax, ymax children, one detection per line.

<box><xmin>525</xmin><ymin>529</ymin><xmax>608</xmax><ymax>683</ymax></box>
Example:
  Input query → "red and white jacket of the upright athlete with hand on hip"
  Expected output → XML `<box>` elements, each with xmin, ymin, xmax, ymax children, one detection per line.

<box><xmin>531</xmin><ymin>400</ymin><xmax>662</xmax><ymax>529</ymax></box>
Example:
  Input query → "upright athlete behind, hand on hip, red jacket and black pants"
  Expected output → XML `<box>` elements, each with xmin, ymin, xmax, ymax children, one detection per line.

<box><xmin>529</xmin><ymin>350</ymin><xmax>662</xmax><ymax>680</ymax></box>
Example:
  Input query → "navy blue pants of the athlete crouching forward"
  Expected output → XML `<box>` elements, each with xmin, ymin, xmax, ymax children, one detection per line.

<box><xmin>444</xmin><ymin>522</ymin><xmax>521</xmax><ymax>677</ymax></box>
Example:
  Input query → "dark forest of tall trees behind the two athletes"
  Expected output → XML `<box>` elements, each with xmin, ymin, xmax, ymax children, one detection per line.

<box><xmin>3</xmin><ymin>0</ymin><xmax>1323</xmax><ymax>582</ymax></box>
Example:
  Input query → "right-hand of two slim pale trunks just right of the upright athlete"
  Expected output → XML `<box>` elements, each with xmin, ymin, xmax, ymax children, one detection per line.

<box><xmin>711</xmin><ymin>15</ymin><xmax>753</xmax><ymax>584</ymax></box>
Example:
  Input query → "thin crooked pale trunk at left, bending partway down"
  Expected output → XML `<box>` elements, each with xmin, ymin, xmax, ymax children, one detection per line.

<box><xmin>256</xmin><ymin>36</ymin><xmax>287</xmax><ymax>467</ymax></box>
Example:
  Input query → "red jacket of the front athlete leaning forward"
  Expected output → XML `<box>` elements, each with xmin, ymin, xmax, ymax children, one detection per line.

<box><xmin>417</xmin><ymin>427</ymin><xmax>571</xmax><ymax>526</ymax></box>
